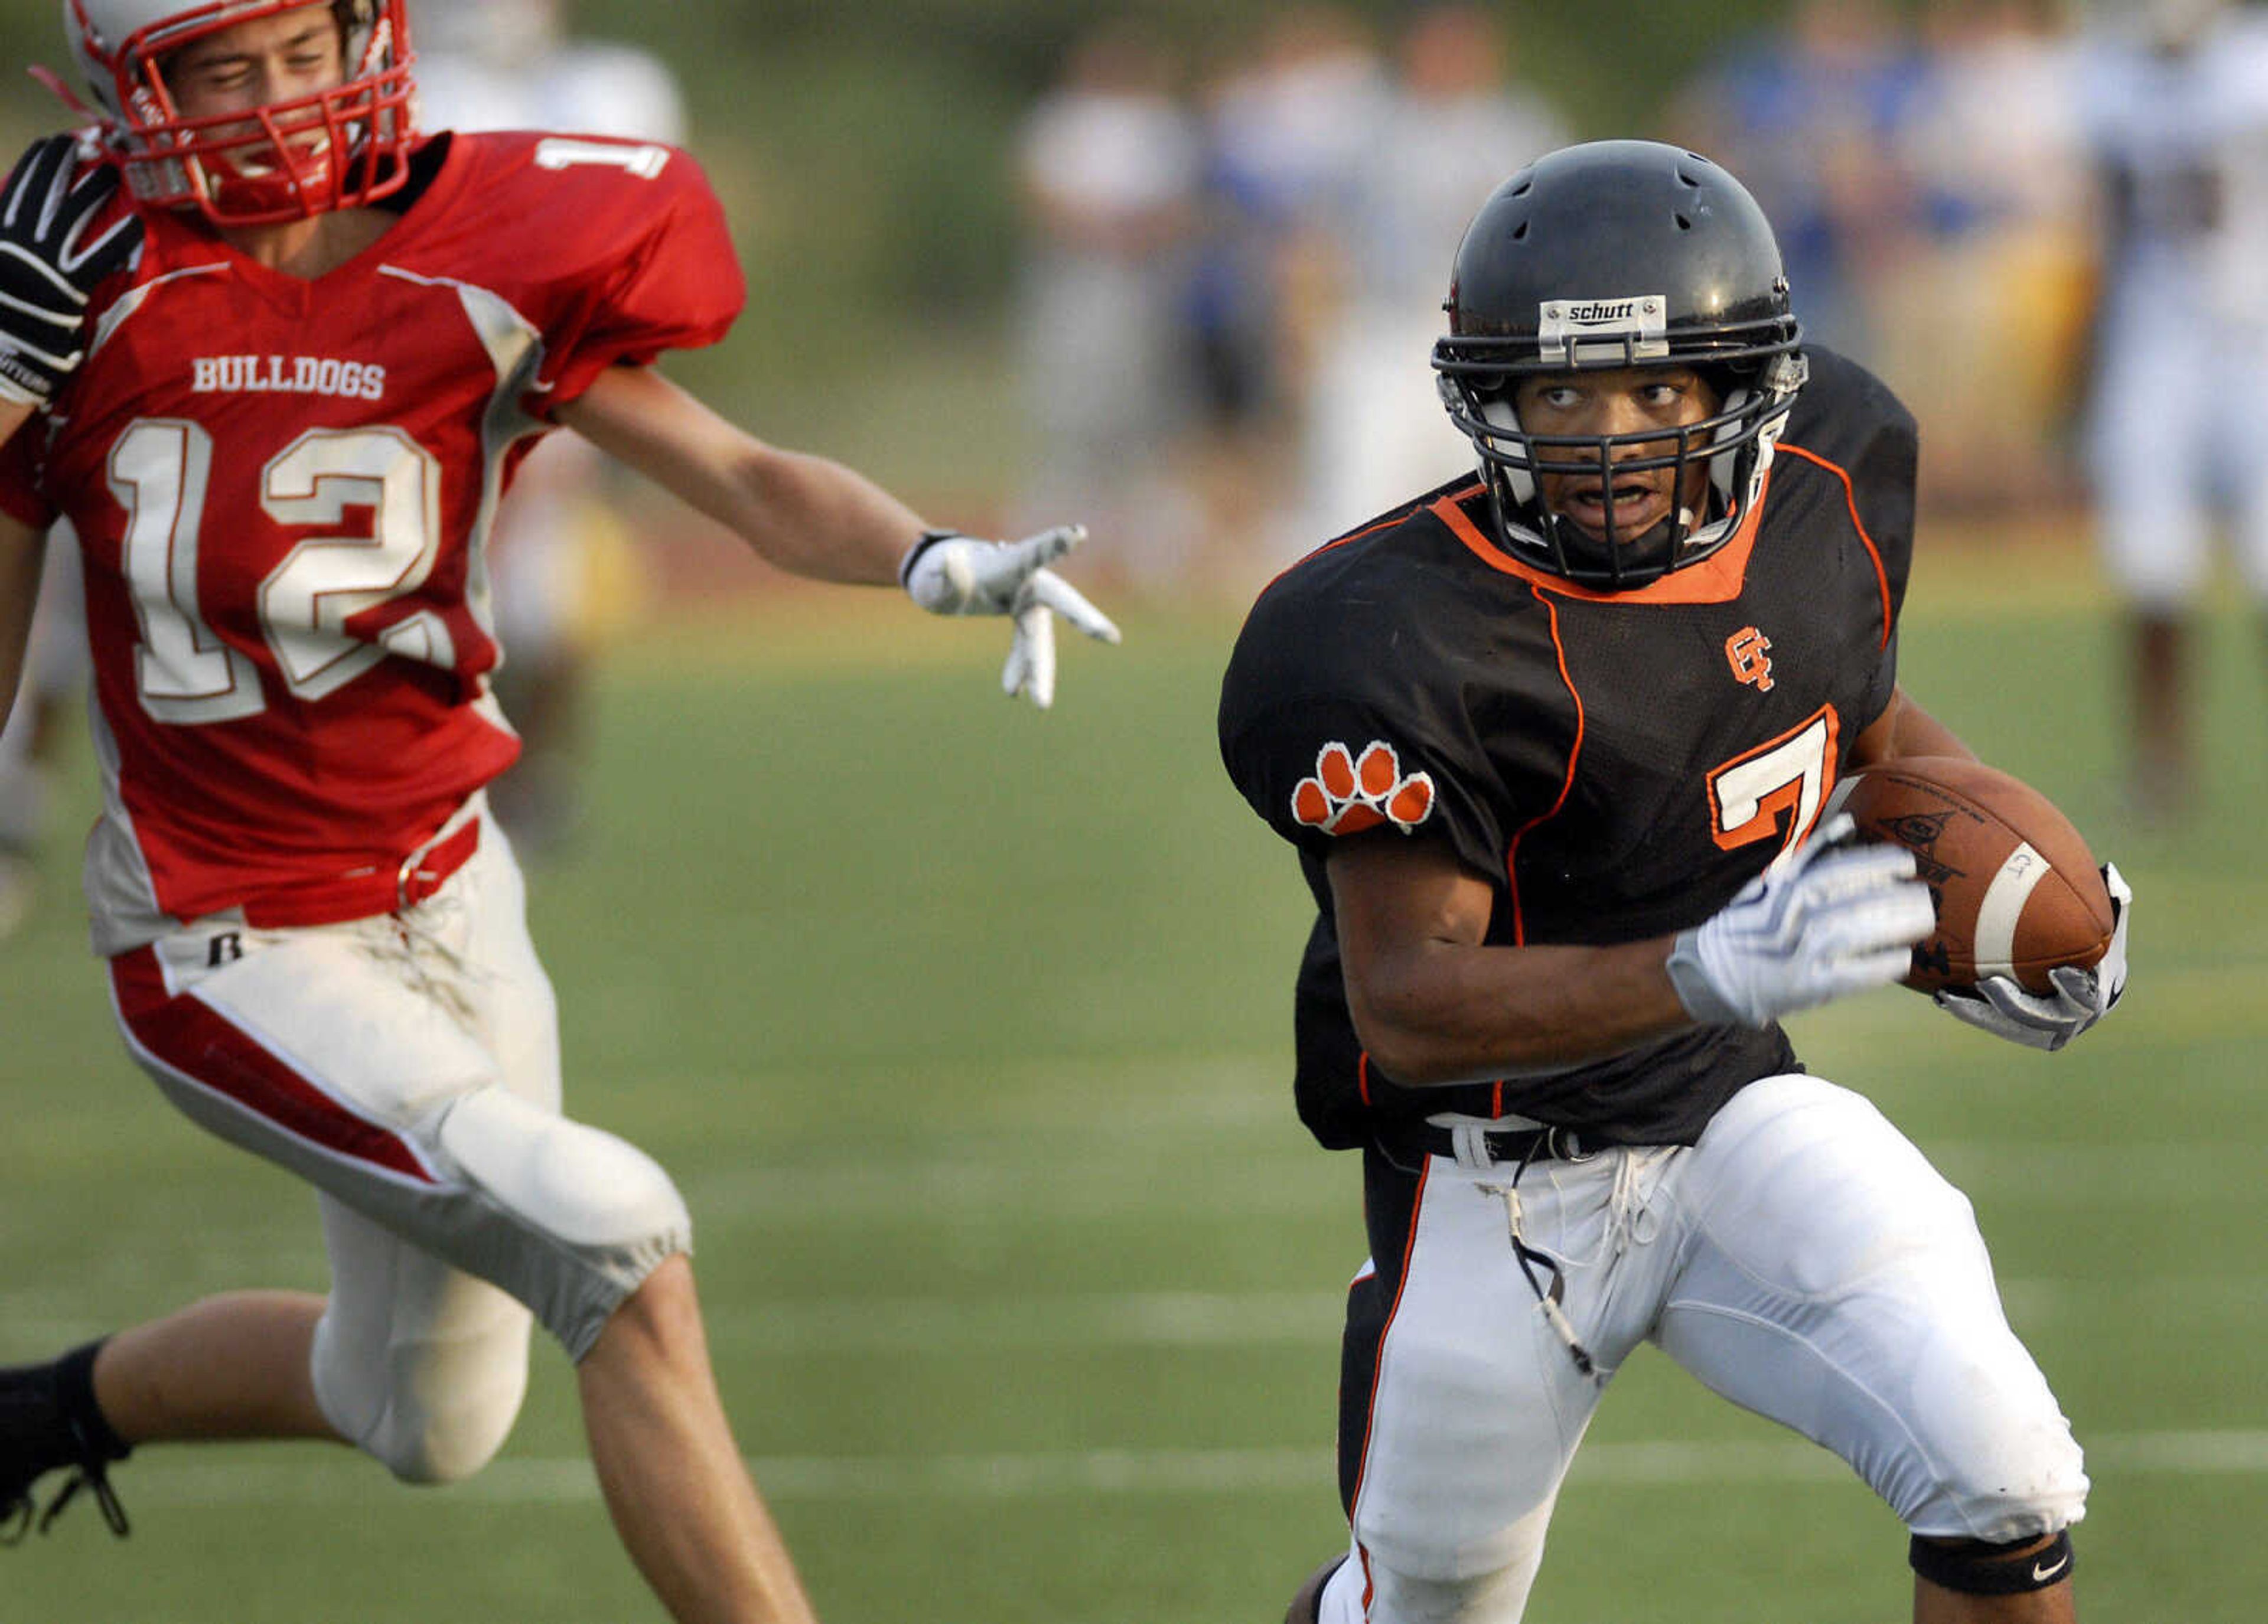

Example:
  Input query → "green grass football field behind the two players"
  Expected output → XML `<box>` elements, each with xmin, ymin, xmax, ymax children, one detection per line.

<box><xmin>0</xmin><ymin>556</ymin><xmax>2268</xmax><ymax>1624</ymax></box>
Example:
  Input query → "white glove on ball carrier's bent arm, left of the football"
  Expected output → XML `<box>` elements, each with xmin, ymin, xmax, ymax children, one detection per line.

<box><xmin>1669</xmin><ymin>812</ymin><xmax>1937</xmax><ymax>1025</ymax></box>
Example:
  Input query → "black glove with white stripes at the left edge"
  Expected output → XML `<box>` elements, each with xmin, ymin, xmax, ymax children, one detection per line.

<box><xmin>0</xmin><ymin>136</ymin><xmax>141</xmax><ymax>406</ymax></box>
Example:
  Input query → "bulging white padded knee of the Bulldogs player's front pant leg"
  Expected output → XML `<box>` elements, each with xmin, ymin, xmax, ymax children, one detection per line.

<box><xmin>433</xmin><ymin>1089</ymin><xmax>692</xmax><ymax>1359</ymax></box>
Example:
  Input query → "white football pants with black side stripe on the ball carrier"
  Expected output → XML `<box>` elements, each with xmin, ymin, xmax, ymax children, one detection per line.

<box><xmin>1322</xmin><ymin>1075</ymin><xmax>2087</xmax><ymax>1624</ymax></box>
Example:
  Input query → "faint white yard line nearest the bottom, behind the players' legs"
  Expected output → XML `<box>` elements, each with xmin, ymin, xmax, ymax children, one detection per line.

<box><xmin>118</xmin><ymin>1431</ymin><xmax>2268</xmax><ymax>1511</ymax></box>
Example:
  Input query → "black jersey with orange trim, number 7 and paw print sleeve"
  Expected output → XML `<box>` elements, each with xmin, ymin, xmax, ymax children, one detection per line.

<box><xmin>1220</xmin><ymin>349</ymin><xmax>1917</xmax><ymax>1147</ymax></box>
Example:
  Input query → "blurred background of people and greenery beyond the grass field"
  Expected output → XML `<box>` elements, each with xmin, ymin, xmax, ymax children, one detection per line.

<box><xmin>0</xmin><ymin>0</ymin><xmax>2268</xmax><ymax>911</ymax></box>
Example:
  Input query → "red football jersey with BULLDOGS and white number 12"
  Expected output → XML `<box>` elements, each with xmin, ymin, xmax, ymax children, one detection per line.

<box><xmin>0</xmin><ymin>134</ymin><xmax>744</xmax><ymax>953</ymax></box>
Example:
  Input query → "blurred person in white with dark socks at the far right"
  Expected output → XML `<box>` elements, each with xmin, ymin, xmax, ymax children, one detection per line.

<box><xmin>2082</xmin><ymin>0</ymin><xmax>2268</xmax><ymax>821</ymax></box>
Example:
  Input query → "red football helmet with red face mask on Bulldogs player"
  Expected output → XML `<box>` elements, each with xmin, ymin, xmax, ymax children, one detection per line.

<box><xmin>64</xmin><ymin>0</ymin><xmax>415</xmax><ymax>227</ymax></box>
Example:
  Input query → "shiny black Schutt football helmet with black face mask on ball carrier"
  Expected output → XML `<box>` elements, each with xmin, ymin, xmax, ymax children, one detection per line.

<box><xmin>1433</xmin><ymin>141</ymin><xmax>1806</xmax><ymax>592</ymax></box>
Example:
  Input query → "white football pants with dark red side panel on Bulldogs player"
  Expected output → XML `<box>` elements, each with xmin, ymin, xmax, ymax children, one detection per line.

<box><xmin>111</xmin><ymin>801</ymin><xmax>692</xmax><ymax>1481</ymax></box>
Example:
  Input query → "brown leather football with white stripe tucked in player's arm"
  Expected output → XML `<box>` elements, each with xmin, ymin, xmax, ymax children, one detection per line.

<box><xmin>1826</xmin><ymin>755</ymin><xmax>2119</xmax><ymax>993</ymax></box>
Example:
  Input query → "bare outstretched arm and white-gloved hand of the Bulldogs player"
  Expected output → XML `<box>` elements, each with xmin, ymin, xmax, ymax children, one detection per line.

<box><xmin>560</xmin><ymin>367</ymin><xmax>1118</xmax><ymax>705</ymax></box>
